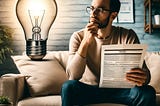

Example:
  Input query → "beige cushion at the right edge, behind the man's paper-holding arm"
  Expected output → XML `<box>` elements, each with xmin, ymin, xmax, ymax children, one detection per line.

<box><xmin>145</xmin><ymin>52</ymin><xmax>160</xmax><ymax>93</ymax></box>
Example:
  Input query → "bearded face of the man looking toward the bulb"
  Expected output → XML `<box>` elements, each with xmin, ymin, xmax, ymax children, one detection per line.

<box><xmin>90</xmin><ymin>0</ymin><xmax>110</xmax><ymax>28</ymax></box>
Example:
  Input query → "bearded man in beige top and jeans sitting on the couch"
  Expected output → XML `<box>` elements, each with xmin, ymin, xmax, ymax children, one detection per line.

<box><xmin>61</xmin><ymin>0</ymin><xmax>156</xmax><ymax>106</ymax></box>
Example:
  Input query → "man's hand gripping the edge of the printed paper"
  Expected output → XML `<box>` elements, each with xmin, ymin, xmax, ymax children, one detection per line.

<box><xmin>126</xmin><ymin>68</ymin><xmax>147</xmax><ymax>86</ymax></box>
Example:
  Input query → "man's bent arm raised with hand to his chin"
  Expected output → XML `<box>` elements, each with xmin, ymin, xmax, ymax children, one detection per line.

<box><xmin>66</xmin><ymin>22</ymin><xmax>98</xmax><ymax>80</ymax></box>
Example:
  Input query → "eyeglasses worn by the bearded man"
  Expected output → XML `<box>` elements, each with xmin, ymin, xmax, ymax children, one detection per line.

<box><xmin>86</xmin><ymin>6</ymin><xmax>112</xmax><ymax>14</ymax></box>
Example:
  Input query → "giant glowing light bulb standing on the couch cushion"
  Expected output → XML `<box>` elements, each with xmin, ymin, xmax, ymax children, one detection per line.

<box><xmin>16</xmin><ymin>0</ymin><xmax>57</xmax><ymax>60</ymax></box>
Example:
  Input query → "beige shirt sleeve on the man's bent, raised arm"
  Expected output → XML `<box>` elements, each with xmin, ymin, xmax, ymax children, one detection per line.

<box><xmin>66</xmin><ymin>33</ymin><xmax>86</xmax><ymax>80</ymax></box>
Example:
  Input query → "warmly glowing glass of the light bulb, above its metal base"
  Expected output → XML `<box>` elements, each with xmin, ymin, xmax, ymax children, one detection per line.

<box><xmin>16</xmin><ymin>0</ymin><xmax>57</xmax><ymax>40</ymax></box>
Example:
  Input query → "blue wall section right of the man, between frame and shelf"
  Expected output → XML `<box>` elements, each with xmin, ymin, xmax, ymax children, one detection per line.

<box><xmin>119</xmin><ymin>0</ymin><xmax>160</xmax><ymax>51</ymax></box>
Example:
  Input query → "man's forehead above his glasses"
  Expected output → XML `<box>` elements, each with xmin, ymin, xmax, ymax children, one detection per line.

<box><xmin>92</xmin><ymin>0</ymin><xmax>110</xmax><ymax>8</ymax></box>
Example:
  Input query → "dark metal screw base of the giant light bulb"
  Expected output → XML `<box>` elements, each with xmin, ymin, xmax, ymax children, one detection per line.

<box><xmin>26</xmin><ymin>39</ymin><xmax>46</xmax><ymax>61</ymax></box>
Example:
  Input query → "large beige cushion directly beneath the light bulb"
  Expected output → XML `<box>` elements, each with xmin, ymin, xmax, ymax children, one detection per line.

<box><xmin>12</xmin><ymin>53</ymin><xmax>67</xmax><ymax>96</ymax></box>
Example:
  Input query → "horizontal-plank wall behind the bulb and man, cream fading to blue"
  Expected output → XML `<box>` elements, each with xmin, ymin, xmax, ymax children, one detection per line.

<box><xmin>0</xmin><ymin>0</ymin><xmax>160</xmax><ymax>73</ymax></box>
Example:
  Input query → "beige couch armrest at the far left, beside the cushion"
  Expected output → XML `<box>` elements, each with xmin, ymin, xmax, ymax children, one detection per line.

<box><xmin>0</xmin><ymin>74</ymin><xmax>25</xmax><ymax>106</ymax></box>
